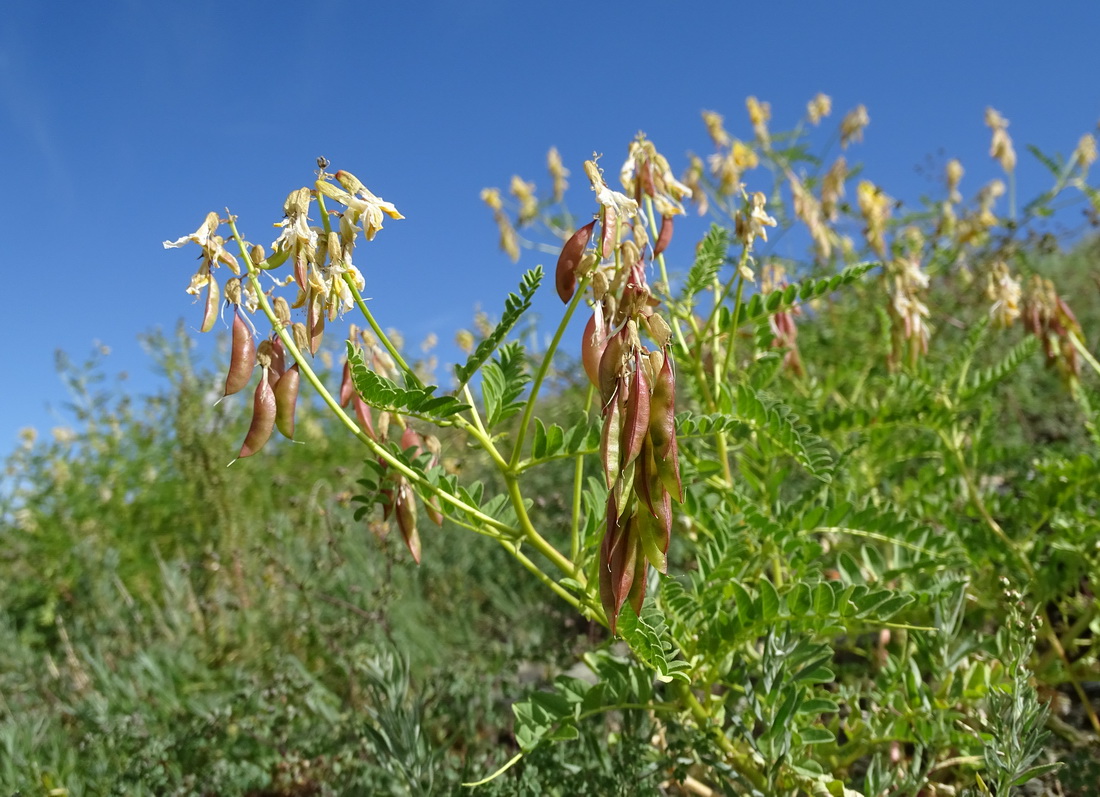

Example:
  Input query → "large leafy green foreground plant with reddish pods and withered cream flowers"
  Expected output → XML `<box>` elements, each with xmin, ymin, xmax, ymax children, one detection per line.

<box><xmin>165</xmin><ymin>96</ymin><xmax>1100</xmax><ymax>796</ymax></box>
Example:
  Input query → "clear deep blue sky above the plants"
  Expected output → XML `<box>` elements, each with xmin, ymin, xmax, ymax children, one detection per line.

<box><xmin>0</xmin><ymin>0</ymin><xmax>1100</xmax><ymax>452</ymax></box>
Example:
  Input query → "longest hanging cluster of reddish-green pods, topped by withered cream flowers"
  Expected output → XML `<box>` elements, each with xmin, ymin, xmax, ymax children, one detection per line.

<box><xmin>556</xmin><ymin>146</ymin><xmax>683</xmax><ymax>633</ymax></box>
